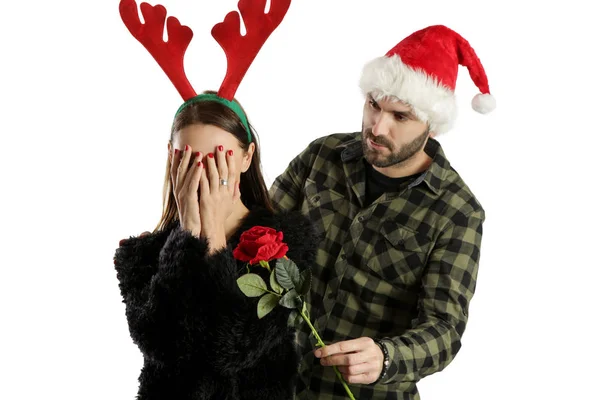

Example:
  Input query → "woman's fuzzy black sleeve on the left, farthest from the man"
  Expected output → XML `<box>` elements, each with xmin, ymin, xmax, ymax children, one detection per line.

<box><xmin>115</xmin><ymin>226</ymin><xmax>230</xmax><ymax>364</ymax></box>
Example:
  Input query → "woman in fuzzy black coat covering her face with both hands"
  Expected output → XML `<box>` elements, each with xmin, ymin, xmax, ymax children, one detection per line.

<box><xmin>115</xmin><ymin>91</ymin><xmax>317</xmax><ymax>400</ymax></box>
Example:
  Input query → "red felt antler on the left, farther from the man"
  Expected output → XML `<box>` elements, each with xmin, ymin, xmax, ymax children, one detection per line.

<box><xmin>119</xmin><ymin>0</ymin><xmax>196</xmax><ymax>100</ymax></box>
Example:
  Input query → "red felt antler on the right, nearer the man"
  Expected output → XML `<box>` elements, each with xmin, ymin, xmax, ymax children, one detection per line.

<box><xmin>212</xmin><ymin>0</ymin><xmax>291</xmax><ymax>100</ymax></box>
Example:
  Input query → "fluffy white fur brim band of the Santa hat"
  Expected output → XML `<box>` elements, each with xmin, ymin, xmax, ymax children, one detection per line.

<box><xmin>360</xmin><ymin>55</ymin><xmax>456</xmax><ymax>135</ymax></box>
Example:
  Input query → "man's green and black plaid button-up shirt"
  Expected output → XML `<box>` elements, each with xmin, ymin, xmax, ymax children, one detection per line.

<box><xmin>271</xmin><ymin>133</ymin><xmax>485</xmax><ymax>400</ymax></box>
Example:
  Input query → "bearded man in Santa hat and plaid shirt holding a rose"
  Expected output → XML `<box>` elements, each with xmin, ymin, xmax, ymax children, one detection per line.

<box><xmin>271</xmin><ymin>26</ymin><xmax>495</xmax><ymax>400</ymax></box>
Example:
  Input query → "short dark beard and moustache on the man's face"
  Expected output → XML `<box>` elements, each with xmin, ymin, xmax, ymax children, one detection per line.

<box><xmin>362</xmin><ymin>128</ymin><xmax>429</xmax><ymax>168</ymax></box>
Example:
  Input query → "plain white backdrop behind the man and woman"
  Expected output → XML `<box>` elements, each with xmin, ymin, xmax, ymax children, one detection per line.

<box><xmin>0</xmin><ymin>0</ymin><xmax>600</xmax><ymax>400</ymax></box>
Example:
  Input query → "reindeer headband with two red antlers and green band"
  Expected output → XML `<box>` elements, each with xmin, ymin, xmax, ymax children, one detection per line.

<box><xmin>119</xmin><ymin>0</ymin><xmax>291</xmax><ymax>142</ymax></box>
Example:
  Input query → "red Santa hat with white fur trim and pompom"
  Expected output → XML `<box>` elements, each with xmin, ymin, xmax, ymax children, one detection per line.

<box><xmin>360</xmin><ymin>25</ymin><xmax>496</xmax><ymax>134</ymax></box>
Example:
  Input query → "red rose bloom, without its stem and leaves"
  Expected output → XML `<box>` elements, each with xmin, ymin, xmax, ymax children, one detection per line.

<box><xmin>233</xmin><ymin>226</ymin><xmax>288</xmax><ymax>265</ymax></box>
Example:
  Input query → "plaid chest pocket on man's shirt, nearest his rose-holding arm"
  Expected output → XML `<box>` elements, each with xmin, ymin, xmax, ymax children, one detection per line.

<box><xmin>367</xmin><ymin>221</ymin><xmax>431</xmax><ymax>286</ymax></box>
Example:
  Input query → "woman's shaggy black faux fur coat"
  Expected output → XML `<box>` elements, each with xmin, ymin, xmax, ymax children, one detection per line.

<box><xmin>115</xmin><ymin>208</ymin><xmax>317</xmax><ymax>400</ymax></box>
